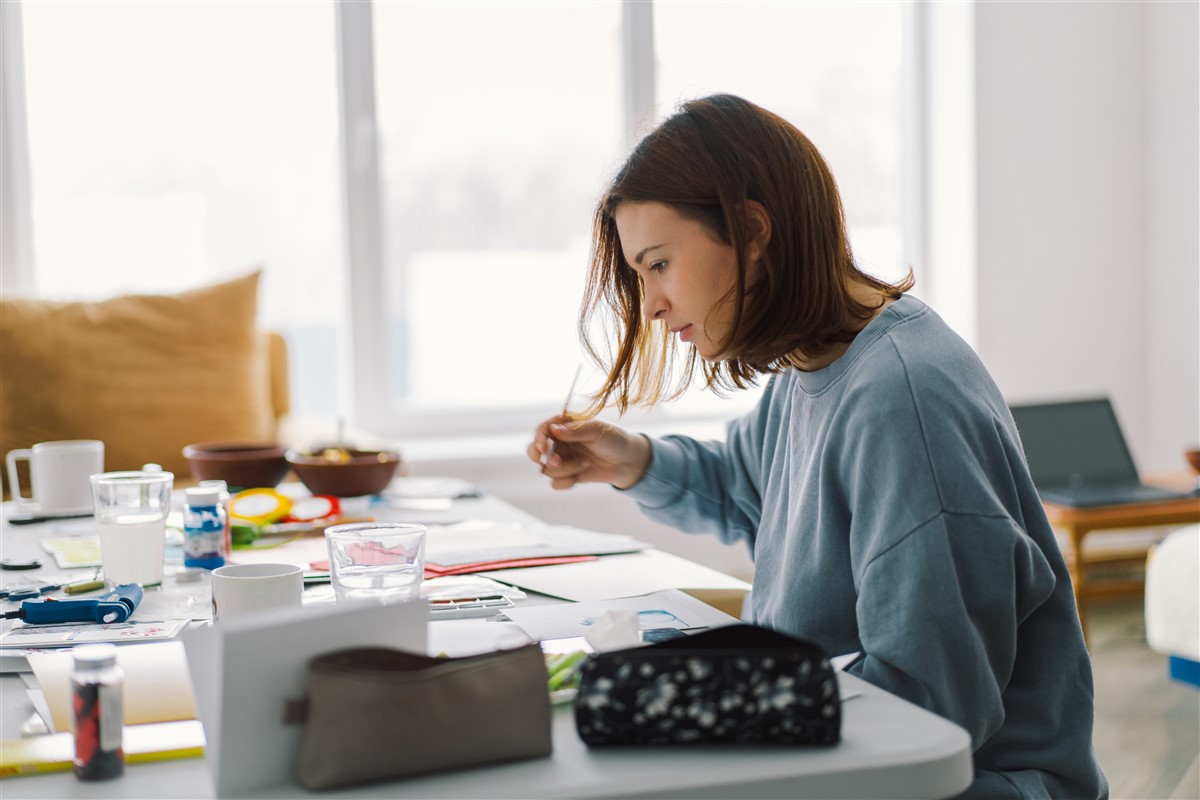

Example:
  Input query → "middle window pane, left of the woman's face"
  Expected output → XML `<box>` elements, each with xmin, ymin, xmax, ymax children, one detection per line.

<box><xmin>374</xmin><ymin>2</ymin><xmax>623</xmax><ymax>415</ymax></box>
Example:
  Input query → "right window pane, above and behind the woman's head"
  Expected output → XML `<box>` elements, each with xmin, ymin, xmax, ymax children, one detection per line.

<box><xmin>654</xmin><ymin>0</ymin><xmax>907</xmax><ymax>287</ymax></box>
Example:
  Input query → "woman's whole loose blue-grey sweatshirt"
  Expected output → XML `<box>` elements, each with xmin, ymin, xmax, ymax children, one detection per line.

<box><xmin>628</xmin><ymin>296</ymin><xmax>1108</xmax><ymax>798</ymax></box>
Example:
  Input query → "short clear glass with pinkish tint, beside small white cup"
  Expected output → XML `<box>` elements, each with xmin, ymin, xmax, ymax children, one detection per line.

<box><xmin>325</xmin><ymin>522</ymin><xmax>426</xmax><ymax>603</ymax></box>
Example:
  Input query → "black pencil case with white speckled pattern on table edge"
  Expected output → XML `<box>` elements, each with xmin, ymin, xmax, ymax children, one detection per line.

<box><xmin>575</xmin><ymin>625</ymin><xmax>841</xmax><ymax>746</ymax></box>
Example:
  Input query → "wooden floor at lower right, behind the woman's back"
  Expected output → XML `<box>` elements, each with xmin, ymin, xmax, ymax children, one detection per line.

<box><xmin>1088</xmin><ymin>597</ymin><xmax>1200</xmax><ymax>800</ymax></box>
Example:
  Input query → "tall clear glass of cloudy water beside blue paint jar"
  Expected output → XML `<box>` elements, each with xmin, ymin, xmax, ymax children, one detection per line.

<box><xmin>91</xmin><ymin>471</ymin><xmax>175</xmax><ymax>587</ymax></box>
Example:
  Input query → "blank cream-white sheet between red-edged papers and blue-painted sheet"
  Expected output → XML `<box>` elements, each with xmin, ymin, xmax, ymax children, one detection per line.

<box><xmin>480</xmin><ymin>549</ymin><xmax>750</xmax><ymax>602</ymax></box>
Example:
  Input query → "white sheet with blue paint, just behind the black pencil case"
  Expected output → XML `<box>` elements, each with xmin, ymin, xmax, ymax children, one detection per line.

<box><xmin>505</xmin><ymin>589</ymin><xmax>738</xmax><ymax>642</ymax></box>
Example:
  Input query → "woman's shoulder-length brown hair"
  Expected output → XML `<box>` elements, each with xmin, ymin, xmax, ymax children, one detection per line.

<box><xmin>580</xmin><ymin>95</ymin><xmax>913</xmax><ymax>415</ymax></box>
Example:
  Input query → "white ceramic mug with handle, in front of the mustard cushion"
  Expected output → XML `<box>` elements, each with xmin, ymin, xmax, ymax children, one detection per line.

<box><xmin>5</xmin><ymin>439</ymin><xmax>104</xmax><ymax>515</ymax></box>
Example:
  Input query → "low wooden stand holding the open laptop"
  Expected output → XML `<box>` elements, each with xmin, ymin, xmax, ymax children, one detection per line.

<box><xmin>1042</xmin><ymin>498</ymin><xmax>1200</xmax><ymax>642</ymax></box>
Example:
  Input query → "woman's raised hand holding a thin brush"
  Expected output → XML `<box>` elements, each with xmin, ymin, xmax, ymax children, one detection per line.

<box><xmin>526</xmin><ymin>416</ymin><xmax>650</xmax><ymax>489</ymax></box>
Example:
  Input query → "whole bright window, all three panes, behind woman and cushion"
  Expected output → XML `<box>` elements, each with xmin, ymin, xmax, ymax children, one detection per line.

<box><xmin>0</xmin><ymin>1</ymin><xmax>906</xmax><ymax>438</ymax></box>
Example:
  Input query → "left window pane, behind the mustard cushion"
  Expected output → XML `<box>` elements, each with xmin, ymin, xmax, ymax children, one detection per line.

<box><xmin>14</xmin><ymin>2</ymin><xmax>346</xmax><ymax>419</ymax></box>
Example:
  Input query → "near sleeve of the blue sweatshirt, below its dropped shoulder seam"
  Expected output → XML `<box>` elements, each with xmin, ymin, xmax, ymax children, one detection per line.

<box><xmin>851</xmin><ymin>512</ymin><xmax>1056</xmax><ymax>748</ymax></box>
